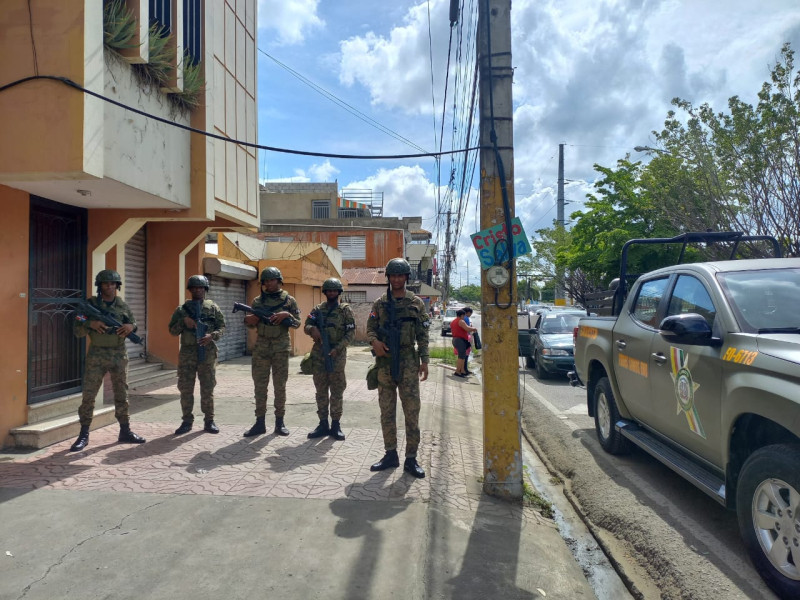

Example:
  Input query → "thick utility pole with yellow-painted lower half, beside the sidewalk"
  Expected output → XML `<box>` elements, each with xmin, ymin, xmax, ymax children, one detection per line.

<box><xmin>477</xmin><ymin>0</ymin><xmax>522</xmax><ymax>499</ymax></box>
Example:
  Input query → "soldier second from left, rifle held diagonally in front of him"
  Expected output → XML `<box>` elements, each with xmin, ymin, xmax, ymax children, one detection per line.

<box><xmin>169</xmin><ymin>275</ymin><xmax>225</xmax><ymax>435</ymax></box>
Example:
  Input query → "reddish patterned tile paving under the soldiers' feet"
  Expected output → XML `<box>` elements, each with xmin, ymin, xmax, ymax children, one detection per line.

<box><xmin>0</xmin><ymin>371</ymin><xmax>494</xmax><ymax>515</ymax></box>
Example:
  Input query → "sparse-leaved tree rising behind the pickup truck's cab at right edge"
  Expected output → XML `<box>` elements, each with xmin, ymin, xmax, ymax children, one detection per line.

<box><xmin>642</xmin><ymin>44</ymin><xmax>800</xmax><ymax>256</ymax></box>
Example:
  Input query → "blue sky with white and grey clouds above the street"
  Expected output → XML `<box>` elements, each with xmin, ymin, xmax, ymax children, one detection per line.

<box><xmin>257</xmin><ymin>0</ymin><xmax>800</xmax><ymax>286</ymax></box>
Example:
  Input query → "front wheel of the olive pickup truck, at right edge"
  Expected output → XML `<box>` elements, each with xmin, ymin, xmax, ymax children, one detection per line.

<box><xmin>736</xmin><ymin>444</ymin><xmax>800</xmax><ymax>598</ymax></box>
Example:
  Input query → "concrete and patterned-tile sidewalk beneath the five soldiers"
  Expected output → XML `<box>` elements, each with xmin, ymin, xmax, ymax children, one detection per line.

<box><xmin>0</xmin><ymin>347</ymin><xmax>594</xmax><ymax>600</ymax></box>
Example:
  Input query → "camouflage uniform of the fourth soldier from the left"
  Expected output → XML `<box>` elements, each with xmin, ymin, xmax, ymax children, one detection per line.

<box><xmin>304</xmin><ymin>302</ymin><xmax>356</xmax><ymax>421</ymax></box>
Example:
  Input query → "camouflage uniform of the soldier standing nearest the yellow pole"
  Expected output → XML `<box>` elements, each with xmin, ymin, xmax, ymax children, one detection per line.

<box><xmin>367</xmin><ymin>291</ymin><xmax>430</xmax><ymax>458</ymax></box>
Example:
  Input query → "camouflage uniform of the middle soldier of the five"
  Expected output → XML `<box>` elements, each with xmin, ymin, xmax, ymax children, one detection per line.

<box><xmin>248</xmin><ymin>290</ymin><xmax>300</xmax><ymax>418</ymax></box>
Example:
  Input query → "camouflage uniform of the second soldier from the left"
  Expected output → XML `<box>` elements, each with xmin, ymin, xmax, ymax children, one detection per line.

<box><xmin>169</xmin><ymin>299</ymin><xmax>225</xmax><ymax>423</ymax></box>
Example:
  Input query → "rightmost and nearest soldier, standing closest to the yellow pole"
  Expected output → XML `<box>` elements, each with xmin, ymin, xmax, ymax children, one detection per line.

<box><xmin>367</xmin><ymin>258</ymin><xmax>430</xmax><ymax>477</ymax></box>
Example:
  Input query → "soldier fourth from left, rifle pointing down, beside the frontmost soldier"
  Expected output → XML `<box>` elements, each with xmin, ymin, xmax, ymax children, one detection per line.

<box><xmin>303</xmin><ymin>277</ymin><xmax>356</xmax><ymax>440</ymax></box>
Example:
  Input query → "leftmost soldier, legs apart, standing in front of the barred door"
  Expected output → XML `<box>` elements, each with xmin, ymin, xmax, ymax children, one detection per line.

<box><xmin>70</xmin><ymin>269</ymin><xmax>145</xmax><ymax>452</ymax></box>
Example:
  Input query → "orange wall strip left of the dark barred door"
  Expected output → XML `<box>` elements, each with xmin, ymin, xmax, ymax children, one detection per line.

<box><xmin>0</xmin><ymin>185</ymin><xmax>30</xmax><ymax>447</ymax></box>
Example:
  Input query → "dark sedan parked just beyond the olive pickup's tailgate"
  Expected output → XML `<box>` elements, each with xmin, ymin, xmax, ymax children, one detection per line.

<box><xmin>531</xmin><ymin>310</ymin><xmax>586</xmax><ymax>379</ymax></box>
